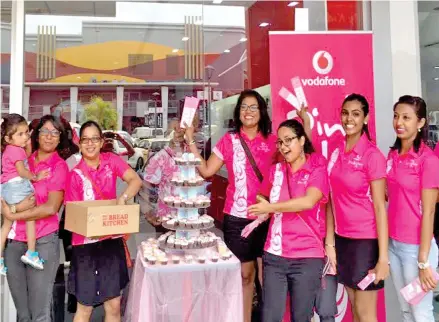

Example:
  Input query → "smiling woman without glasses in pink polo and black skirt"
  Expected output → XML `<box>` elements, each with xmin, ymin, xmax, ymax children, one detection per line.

<box><xmin>325</xmin><ymin>94</ymin><xmax>389</xmax><ymax>322</ymax></box>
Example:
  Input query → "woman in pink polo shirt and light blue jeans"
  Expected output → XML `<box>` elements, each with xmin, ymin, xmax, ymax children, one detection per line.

<box><xmin>387</xmin><ymin>95</ymin><xmax>439</xmax><ymax>322</ymax></box>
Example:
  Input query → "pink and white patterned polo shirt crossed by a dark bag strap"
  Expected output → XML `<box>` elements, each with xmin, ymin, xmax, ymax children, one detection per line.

<box><xmin>213</xmin><ymin>131</ymin><xmax>276</xmax><ymax>218</ymax></box>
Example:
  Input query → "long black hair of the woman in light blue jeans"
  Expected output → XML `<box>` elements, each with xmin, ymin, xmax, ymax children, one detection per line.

<box><xmin>390</xmin><ymin>95</ymin><xmax>428</xmax><ymax>153</ymax></box>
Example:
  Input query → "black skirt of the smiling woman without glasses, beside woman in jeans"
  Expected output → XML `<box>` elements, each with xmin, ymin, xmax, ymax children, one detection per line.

<box><xmin>335</xmin><ymin>235</ymin><xmax>384</xmax><ymax>291</ymax></box>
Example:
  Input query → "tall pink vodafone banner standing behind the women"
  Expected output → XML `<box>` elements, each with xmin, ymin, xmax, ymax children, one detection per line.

<box><xmin>269</xmin><ymin>31</ymin><xmax>386</xmax><ymax>322</ymax></box>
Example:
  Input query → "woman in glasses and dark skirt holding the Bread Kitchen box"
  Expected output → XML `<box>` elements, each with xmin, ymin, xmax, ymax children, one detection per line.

<box><xmin>66</xmin><ymin>121</ymin><xmax>142</xmax><ymax>322</ymax></box>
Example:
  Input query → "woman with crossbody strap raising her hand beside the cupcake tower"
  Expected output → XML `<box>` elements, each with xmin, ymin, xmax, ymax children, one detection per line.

<box><xmin>186</xmin><ymin>90</ymin><xmax>276</xmax><ymax>322</ymax></box>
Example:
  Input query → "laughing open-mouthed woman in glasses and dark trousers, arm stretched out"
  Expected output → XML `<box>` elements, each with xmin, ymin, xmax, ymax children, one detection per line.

<box><xmin>248</xmin><ymin>120</ymin><xmax>329</xmax><ymax>322</ymax></box>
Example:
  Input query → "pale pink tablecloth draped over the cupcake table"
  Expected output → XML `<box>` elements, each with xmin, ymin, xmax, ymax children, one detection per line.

<box><xmin>124</xmin><ymin>250</ymin><xmax>243</xmax><ymax>322</ymax></box>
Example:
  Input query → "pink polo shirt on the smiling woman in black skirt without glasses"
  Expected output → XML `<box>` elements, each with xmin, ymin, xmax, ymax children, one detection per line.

<box><xmin>328</xmin><ymin>134</ymin><xmax>386</xmax><ymax>239</ymax></box>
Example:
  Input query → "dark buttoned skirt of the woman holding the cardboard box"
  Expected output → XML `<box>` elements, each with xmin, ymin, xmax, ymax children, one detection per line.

<box><xmin>67</xmin><ymin>238</ymin><xmax>129</xmax><ymax>306</ymax></box>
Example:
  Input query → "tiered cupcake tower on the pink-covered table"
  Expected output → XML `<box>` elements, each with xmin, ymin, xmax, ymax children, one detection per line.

<box><xmin>159</xmin><ymin>153</ymin><xmax>217</xmax><ymax>249</ymax></box>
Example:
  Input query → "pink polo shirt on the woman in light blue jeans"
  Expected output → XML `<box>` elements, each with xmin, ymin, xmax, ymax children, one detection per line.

<box><xmin>387</xmin><ymin>143</ymin><xmax>439</xmax><ymax>245</ymax></box>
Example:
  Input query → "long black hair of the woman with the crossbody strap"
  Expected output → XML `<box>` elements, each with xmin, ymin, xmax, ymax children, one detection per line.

<box><xmin>233</xmin><ymin>89</ymin><xmax>271</xmax><ymax>138</ymax></box>
